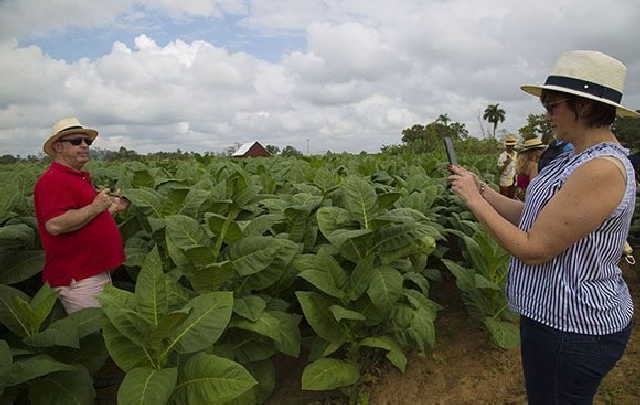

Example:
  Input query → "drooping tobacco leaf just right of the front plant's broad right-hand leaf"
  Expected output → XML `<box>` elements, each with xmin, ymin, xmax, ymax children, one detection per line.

<box><xmin>230</xmin><ymin>311</ymin><xmax>300</xmax><ymax>357</ymax></box>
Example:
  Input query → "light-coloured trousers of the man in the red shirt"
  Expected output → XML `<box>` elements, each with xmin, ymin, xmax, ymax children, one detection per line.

<box><xmin>54</xmin><ymin>271</ymin><xmax>111</xmax><ymax>314</ymax></box>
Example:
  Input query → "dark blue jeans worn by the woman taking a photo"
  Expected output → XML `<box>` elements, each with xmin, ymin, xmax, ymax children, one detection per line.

<box><xmin>520</xmin><ymin>316</ymin><xmax>631</xmax><ymax>405</ymax></box>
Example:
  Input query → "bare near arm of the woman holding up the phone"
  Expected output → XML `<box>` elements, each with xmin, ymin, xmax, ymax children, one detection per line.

<box><xmin>449</xmin><ymin>159</ymin><xmax>625</xmax><ymax>264</ymax></box>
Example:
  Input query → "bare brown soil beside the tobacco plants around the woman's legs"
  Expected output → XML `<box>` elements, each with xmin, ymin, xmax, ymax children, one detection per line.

<box><xmin>267</xmin><ymin>265</ymin><xmax>640</xmax><ymax>405</ymax></box>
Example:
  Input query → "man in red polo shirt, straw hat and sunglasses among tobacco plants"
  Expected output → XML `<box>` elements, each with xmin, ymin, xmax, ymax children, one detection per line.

<box><xmin>34</xmin><ymin>118</ymin><xmax>128</xmax><ymax>313</ymax></box>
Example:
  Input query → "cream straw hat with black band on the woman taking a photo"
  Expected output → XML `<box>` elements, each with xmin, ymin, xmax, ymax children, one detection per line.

<box><xmin>520</xmin><ymin>51</ymin><xmax>640</xmax><ymax>118</ymax></box>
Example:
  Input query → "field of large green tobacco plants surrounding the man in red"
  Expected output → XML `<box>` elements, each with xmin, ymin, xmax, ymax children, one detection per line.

<box><xmin>0</xmin><ymin>153</ymin><xmax>548</xmax><ymax>405</ymax></box>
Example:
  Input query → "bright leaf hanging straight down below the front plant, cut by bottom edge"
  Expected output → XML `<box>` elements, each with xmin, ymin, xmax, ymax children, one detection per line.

<box><xmin>118</xmin><ymin>367</ymin><xmax>178</xmax><ymax>405</ymax></box>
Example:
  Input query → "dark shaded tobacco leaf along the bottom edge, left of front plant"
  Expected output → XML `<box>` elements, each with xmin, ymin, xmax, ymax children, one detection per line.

<box><xmin>29</xmin><ymin>368</ymin><xmax>96</xmax><ymax>405</ymax></box>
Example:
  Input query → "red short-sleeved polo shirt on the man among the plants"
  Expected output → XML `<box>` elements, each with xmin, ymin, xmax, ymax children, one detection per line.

<box><xmin>34</xmin><ymin>162</ymin><xmax>125</xmax><ymax>287</ymax></box>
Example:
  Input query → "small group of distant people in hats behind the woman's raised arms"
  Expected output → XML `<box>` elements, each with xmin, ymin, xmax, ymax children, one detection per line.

<box><xmin>498</xmin><ymin>135</ymin><xmax>573</xmax><ymax>201</ymax></box>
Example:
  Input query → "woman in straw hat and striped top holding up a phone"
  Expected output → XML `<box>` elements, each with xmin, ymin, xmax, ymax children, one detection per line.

<box><xmin>449</xmin><ymin>51</ymin><xmax>640</xmax><ymax>405</ymax></box>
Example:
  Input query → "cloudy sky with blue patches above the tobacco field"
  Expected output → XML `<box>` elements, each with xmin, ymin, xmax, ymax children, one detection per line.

<box><xmin>0</xmin><ymin>0</ymin><xmax>640</xmax><ymax>155</ymax></box>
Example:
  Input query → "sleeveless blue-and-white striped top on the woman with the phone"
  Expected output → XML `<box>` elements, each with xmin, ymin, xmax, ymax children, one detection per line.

<box><xmin>506</xmin><ymin>143</ymin><xmax>636</xmax><ymax>335</ymax></box>
